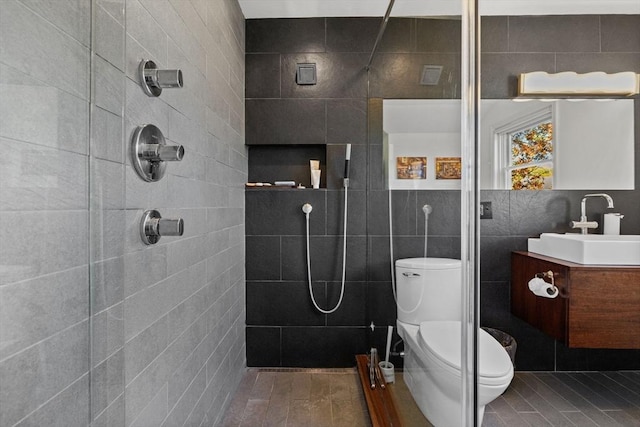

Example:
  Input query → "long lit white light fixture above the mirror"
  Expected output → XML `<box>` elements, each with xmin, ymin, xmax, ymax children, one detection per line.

<box><xmin>518</xmin><ymin>71</ymin><xmax>640</xmax><ymax>96</ymax></box>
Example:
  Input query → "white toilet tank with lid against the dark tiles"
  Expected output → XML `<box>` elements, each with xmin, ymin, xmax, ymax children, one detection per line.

<box><xmin>396</xmin><ymin>258</ymin><xmax>462</xmax><ymax>325</ymax></box>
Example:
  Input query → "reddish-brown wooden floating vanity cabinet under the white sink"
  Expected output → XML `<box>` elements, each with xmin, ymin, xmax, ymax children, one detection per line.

<box><xmin>511</xmin><ymin>252</ymin><xmax>640</xmax><ymax>349</ymax></box>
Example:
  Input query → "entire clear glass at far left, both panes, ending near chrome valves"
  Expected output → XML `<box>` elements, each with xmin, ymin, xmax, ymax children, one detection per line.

<box><xmin>0</xmin><ymin>0</ymin><xmax>126</xmax><ymax>427</ymax></box>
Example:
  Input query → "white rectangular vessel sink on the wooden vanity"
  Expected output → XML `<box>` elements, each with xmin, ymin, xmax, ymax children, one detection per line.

<box><xmin>528</xmin><ymin>233</ymin><xmax>640</xmax><ymax>265</ymax></box>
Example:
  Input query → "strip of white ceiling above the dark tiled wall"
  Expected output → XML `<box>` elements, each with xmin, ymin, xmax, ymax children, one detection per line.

<box><xmin>239</xmin><ymin>0</ymin><xmax>640</xmax><ymax>19</ymax></box>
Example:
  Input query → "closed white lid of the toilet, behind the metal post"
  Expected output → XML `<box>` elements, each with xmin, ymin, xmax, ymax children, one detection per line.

<box><xmin>418</xmin><ymin>320</ymin><xmax>513</xmax><ymax>382</ymax></box>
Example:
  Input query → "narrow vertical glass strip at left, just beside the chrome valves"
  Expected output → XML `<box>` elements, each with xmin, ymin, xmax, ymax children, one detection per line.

<box><xmin>89</xmin><ymin>0</ymin><xmax>127</xmax><ymax>427</ymax></box>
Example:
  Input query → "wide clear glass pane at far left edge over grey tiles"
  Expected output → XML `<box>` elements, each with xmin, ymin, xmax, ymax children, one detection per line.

<box><xmin>0</xmin><ymin>0</ymin><xmax>92</xmax><ymax>426</ymax></box>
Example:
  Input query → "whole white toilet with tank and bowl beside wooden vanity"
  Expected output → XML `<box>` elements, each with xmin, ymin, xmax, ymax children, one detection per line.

<box><xmin>396</xmin><ymin>258</ymin><xmax>513</xmax><ymax>427</ymax></box>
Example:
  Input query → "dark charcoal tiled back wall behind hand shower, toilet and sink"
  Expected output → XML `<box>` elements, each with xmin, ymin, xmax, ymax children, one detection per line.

<box><xmin>246</xmin><ymin>15</ymin><xmax>640</xmax><ymax>370</ymax></box>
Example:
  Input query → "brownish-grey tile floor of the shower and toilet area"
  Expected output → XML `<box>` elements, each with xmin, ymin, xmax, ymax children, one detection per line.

<box><xmin>222</xmin><ymin>369</ymin><xmax>640</xmax><ymax>427</ymax></box>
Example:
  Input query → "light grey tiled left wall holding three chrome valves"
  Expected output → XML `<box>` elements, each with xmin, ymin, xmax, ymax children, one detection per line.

<box><xmin>0</xmin><ymin>0</ymin><xmax>247</xmax><ymax>427</ymax></box>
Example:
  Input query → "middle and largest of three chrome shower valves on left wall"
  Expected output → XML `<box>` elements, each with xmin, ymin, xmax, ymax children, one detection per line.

<box><xmin>131</xmin><ymin>125</ymin><xmax>184</xmax><ymax>182</ymax></box>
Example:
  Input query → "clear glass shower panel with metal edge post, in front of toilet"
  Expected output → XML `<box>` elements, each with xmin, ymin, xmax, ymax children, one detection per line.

<box><xmin>369</xmin><ymin>0</ymin><xmax>484</xmax><ymax>426</ymax></box>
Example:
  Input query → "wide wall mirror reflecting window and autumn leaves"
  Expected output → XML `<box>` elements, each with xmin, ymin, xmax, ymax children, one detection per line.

<box><xmin>383</xmin><ymin>99</ymin><xmax>634</xmax><ymax>190</ymax></box>
